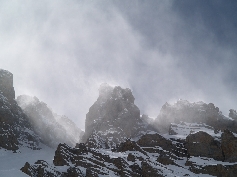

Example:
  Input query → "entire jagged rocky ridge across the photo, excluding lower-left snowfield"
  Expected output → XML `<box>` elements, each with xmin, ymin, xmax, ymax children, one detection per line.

<box><xmin>0</xmin><ymin>70</ymin><xmax>237</xmax><ymax>177</ymax></box>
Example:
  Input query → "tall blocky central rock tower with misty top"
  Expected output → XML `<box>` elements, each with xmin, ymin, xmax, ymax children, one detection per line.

<box><xmin>83</xmin><ymin>84</ymin><xmax>154</xmax><ymax>148</ymax></box>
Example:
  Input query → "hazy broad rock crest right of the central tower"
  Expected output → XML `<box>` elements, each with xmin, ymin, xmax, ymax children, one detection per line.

<box><xmin>154</xmin><ymin>100</ymin><xmax>233</xmax><ymax>133</ymax></box>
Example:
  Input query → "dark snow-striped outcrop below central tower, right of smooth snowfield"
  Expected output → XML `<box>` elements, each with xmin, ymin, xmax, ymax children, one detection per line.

<box><xmin>53</xmin><ymin>144</ymin><xmax>144</xmax><ymax>176</ymax></box>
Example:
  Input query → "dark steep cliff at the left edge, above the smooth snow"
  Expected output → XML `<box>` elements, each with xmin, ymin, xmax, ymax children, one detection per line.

<box><xmin>0</xmin><ymin>70</ymin><xmax>39</xmax><ymax>151</ymax></box>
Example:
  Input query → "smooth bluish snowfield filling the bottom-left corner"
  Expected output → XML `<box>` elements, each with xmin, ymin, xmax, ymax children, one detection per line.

<box><xmin>0</xmin><ymin>144</ymin><xmax>55</xmax><ymax>177</ymax></box>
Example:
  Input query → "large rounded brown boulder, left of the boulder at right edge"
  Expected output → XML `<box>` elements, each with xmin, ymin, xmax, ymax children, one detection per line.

<box><xmin>185</xmin><ymin>131</ymin><xmax>224</xmax><ymax>161</ymax></box>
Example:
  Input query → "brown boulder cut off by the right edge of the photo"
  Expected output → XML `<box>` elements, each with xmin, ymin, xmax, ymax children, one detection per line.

<box><xmin>221</xmin><ymin>130</ymin><xmax>237</xmax><ymax>162</ymax></box>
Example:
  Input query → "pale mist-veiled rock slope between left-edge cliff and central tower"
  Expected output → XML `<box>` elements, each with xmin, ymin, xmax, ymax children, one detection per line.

<box><xmin>17</xmin><ymin>95</ymin><xmax>82</xmax><ymax>148</ymax></box>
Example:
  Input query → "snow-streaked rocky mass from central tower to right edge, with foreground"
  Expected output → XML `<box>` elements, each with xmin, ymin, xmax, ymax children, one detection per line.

<box><xmin>21</xmin><ymin>84</ymin><xmax>237</xmax><ymax>177</ymax></box>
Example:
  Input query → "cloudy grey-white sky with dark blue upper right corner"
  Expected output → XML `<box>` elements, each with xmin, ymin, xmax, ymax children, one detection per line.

<box><xmin>0</xmin><ymin>0</ymin><xmax>237</xmax><ymax>129</ymax></box>
